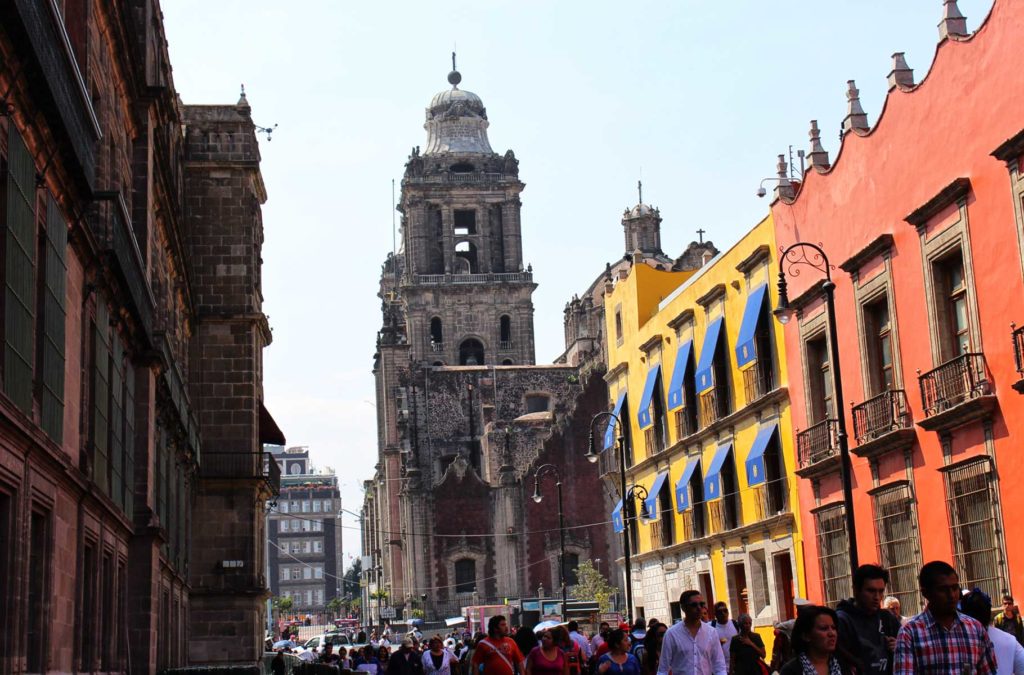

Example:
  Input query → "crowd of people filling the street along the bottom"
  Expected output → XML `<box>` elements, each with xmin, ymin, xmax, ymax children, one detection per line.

<box><xmin>276</xmin><ymin>561</ymin><xmax>1024</xmax><ymax>675</ymax></box>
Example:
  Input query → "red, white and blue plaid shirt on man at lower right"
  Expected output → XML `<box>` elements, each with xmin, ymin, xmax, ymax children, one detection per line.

<box><xmin>893</xmin><ymin>608</ymin><xmax>995</xmax><ymax>675</ymax></box>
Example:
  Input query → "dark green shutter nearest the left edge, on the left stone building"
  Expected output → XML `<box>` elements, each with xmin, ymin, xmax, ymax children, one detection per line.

<box><xmin>3</xmin><ymin>125</ymin><xmax>36</xmax><ymax>415</ymax></box>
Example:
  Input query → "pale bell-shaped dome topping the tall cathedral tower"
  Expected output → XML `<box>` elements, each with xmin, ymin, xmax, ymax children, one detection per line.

<box><xmin>423</xmin><ymin>70</ymin><xmax>494</xmax><ymax>155</ymax></box>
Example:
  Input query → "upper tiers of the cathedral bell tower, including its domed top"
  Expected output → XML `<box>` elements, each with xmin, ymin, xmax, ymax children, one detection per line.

<box><xmin>398</xmin><ymin>61</ymin><xmax>537</xmax><ymax>366</ymax></box>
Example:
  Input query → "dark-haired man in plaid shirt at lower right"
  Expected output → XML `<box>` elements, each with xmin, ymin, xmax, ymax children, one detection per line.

<box><xmin>893</xmin><ymin>560</ymin><xmax>995</xmax><ymax>675</ymax></box>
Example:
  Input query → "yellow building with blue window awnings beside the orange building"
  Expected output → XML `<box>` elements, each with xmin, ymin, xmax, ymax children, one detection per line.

<box><xmin>599</xmin><ymin>217</ymin><xmax>806</xmax><ymax>644</ymax></box>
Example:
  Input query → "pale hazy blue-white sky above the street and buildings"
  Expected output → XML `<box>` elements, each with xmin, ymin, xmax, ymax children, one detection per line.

<box><xmin>163</xmin><ymin>0</ymin><xmax>1001</xmax><ymax>565</ymax></box>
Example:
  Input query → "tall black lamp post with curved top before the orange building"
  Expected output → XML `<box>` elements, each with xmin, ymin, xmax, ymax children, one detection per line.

<box><xmin>772</xmin><ymin>242</ymin><xmax>858</xmax><ymax>578</ymax></box>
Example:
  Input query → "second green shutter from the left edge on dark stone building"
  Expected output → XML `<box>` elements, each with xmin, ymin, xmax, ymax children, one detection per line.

<box><xmin>40</xmin><ymin>196</ymin><xmax>68</xmax><ymax>444</ymax></box>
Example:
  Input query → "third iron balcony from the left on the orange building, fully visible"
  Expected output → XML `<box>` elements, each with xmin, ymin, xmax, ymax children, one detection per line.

<box><xmin>918</xmin><ymin>352</ymin><xmax>996</xmax><ymax>431</ymax></box>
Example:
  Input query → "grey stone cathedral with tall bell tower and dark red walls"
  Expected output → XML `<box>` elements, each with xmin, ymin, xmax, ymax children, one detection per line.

<box><xmin>362</xmin><ymin>66</ymin><xmax>610</xmax><ymax>619</ymax></box>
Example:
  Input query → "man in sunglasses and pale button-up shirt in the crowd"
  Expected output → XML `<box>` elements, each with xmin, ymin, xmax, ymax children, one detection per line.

<box><xmin>657</xmin><ymin>591</ymin><xmax>726</xmax><ymax>675</ymax></box>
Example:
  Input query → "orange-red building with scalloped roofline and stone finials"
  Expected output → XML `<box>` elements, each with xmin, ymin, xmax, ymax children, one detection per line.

<box><xmin>771</xmin><ymin>0</ymin><xmax>1024</xmax><ymax>615</ymax></box>
